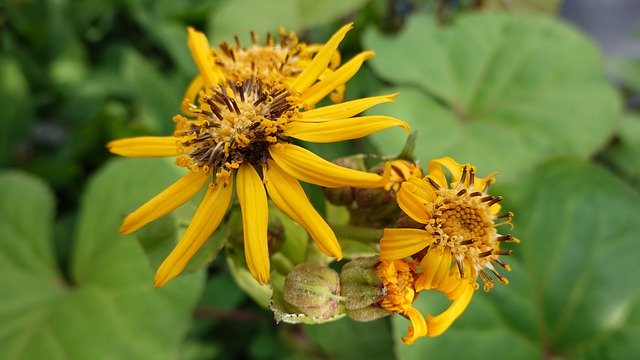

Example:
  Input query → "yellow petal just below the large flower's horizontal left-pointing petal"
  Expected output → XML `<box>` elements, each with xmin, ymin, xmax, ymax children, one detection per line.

<box><xmin>120</xmin><ymin>171</ymin><xmax>209</xmax><ymax>234</ymax></box>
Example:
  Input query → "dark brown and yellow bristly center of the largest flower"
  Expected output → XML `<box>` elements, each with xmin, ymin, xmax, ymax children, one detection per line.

<box><xmin>174</xmin><ymin>77</ymin><xmax>299</xmax><ymax>178</ymax></box>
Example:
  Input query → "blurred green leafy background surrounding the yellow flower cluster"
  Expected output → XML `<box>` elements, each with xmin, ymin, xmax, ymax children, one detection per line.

<box><xmin>0</xmin><ymin>0</ymin><xmax>640</xmax><ymax>359</ymax></box>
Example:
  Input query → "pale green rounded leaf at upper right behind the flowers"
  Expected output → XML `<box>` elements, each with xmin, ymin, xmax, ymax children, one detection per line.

<box><xmin>364</xmin><ymin>14</ymin><xmax>619</xmax><ymax>180</ymax></box>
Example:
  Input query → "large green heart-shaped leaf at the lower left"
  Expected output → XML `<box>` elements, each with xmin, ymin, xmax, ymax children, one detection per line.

<box><xmin>0</xmin><ymin>160</ymin><xmax>202</xmax><ymax>359</ymax></box>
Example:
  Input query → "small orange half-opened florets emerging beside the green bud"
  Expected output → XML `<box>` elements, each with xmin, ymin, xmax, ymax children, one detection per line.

<box><xmin>376</xmin><ymin>260</ymin><xmax>416</xmax><ymax>314</ymax></box>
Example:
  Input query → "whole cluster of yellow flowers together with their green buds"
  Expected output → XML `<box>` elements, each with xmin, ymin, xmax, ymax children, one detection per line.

<box><xmin>107</xmin><ymin>24</ymin><xmax>518</xmax><ymax>344</ymax></box>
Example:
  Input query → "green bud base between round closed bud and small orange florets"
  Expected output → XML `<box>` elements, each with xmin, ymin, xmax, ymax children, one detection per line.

<box><xmin>340</xmin><ymin>256</ymin><xmax>391</xmax><ymax>321</ymax></box>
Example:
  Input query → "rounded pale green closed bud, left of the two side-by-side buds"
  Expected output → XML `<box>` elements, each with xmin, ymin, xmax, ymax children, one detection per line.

<box><xmin>282</xmin><ymin>263</ymin><xmax>341</xmax><ymax>319</ymax></box>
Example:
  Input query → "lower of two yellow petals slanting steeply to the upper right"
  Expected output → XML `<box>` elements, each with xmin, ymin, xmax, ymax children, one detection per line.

<box><xmin>301</xmin><ymin>51</ymin><xmax>374</xmax><ymax>104</ymax></box>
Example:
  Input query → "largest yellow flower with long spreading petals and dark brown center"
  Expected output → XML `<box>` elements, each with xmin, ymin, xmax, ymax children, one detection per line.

<box><xmin>107</xmin><ymin>25</ymin><xmax>408</xmax><ymax>287</ymax></box>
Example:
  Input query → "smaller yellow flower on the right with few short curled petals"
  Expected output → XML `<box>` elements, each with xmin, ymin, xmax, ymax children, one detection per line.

<box><xmin>380</xmin><ymin>157</ymin><xmax>519</xmax><ymax>336</ymax></box>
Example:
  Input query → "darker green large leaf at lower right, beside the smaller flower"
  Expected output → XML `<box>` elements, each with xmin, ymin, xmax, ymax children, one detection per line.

<box><xmin>394</xmin><ymin>160</ymin><xmax>640</xmax><ymax>359</ymax></box>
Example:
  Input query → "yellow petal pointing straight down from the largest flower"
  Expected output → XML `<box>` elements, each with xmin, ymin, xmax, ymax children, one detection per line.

<box><xmin>236</xmin><ymin>165</ymin><xmax>269</xmax><ymax>284</ymax></box>
